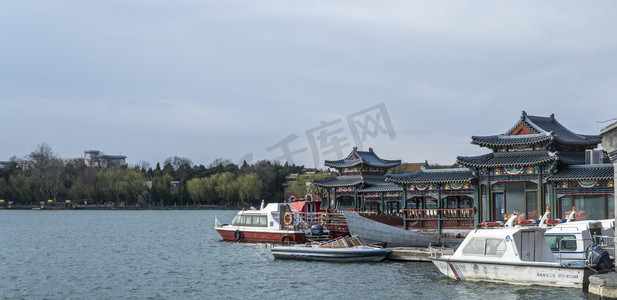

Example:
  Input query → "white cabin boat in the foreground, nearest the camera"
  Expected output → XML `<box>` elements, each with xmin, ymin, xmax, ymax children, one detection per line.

<box><xmin>430</xmin><ymin>215</ymin><xmax>595</xmax><ymax>288</ymax></box>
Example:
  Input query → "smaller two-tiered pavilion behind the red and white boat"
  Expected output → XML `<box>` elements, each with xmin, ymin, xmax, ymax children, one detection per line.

<box><xmin>314</xmin><ymin>147</ymin><xmax>403</xmax><ymax>212</ymax></box>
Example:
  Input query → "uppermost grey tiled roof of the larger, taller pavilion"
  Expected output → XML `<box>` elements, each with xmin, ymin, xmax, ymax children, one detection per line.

<box><xmin>471</xmin><ymin>111</ymin><xmax>602</xmax><ymax>148</ymax></box>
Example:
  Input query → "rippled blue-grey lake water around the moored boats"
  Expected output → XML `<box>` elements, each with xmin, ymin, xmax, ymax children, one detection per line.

<box><xmin>0</xmin><ymin>210</ymin><xmax>587</xmax><ymax>299</ymax></box>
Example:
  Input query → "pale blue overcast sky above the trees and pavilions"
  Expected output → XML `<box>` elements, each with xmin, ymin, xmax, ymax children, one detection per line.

<box><xmin>0</xmin><ymin>0</ymin><xmax>617</xmax><ymax>168</ymax></box>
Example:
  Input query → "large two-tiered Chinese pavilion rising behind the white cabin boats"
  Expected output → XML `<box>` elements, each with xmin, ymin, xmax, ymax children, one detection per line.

<box><xmin>457</xmin><ymin>111</ymin><xmax>613</xmax><ymax>221</ymax></box>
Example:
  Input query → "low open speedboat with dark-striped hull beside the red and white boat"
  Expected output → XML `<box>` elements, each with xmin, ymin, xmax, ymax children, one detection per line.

<box><xmin>272</xmin><ymin>236</ymin><xmax>392</xmax><ymax>262</ymax></box>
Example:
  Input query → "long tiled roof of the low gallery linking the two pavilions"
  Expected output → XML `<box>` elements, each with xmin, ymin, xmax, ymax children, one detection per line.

<box><xmin>387</xmin><ymin>168</ymin><xmax>475</xmax><ymax>184</ymax></box>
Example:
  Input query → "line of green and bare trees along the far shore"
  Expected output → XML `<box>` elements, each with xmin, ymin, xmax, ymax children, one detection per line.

<box><xmin>0</xmin><ymin>143</ymin><xmax>304</xmax><ymax>206</ymax></box>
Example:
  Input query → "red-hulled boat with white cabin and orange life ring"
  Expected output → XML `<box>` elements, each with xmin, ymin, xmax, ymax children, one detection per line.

<box><xmin>214</xmin><ymin>202</ymin><xmax>320</xmax><ymax>243</ymax></box>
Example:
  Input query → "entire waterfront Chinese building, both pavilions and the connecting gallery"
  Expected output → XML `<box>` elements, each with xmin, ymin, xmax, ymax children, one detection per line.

<box><xmin>315</xmin><ymin>111</ymin><xmax>614</xmax><ymax>232</ymax></box>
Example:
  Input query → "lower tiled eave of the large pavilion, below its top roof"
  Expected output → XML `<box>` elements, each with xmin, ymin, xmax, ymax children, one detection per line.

<box><xmin>456</xmin><ymin>150</ymin><xmax>557</xmax><ymax>168</ymax></box>
